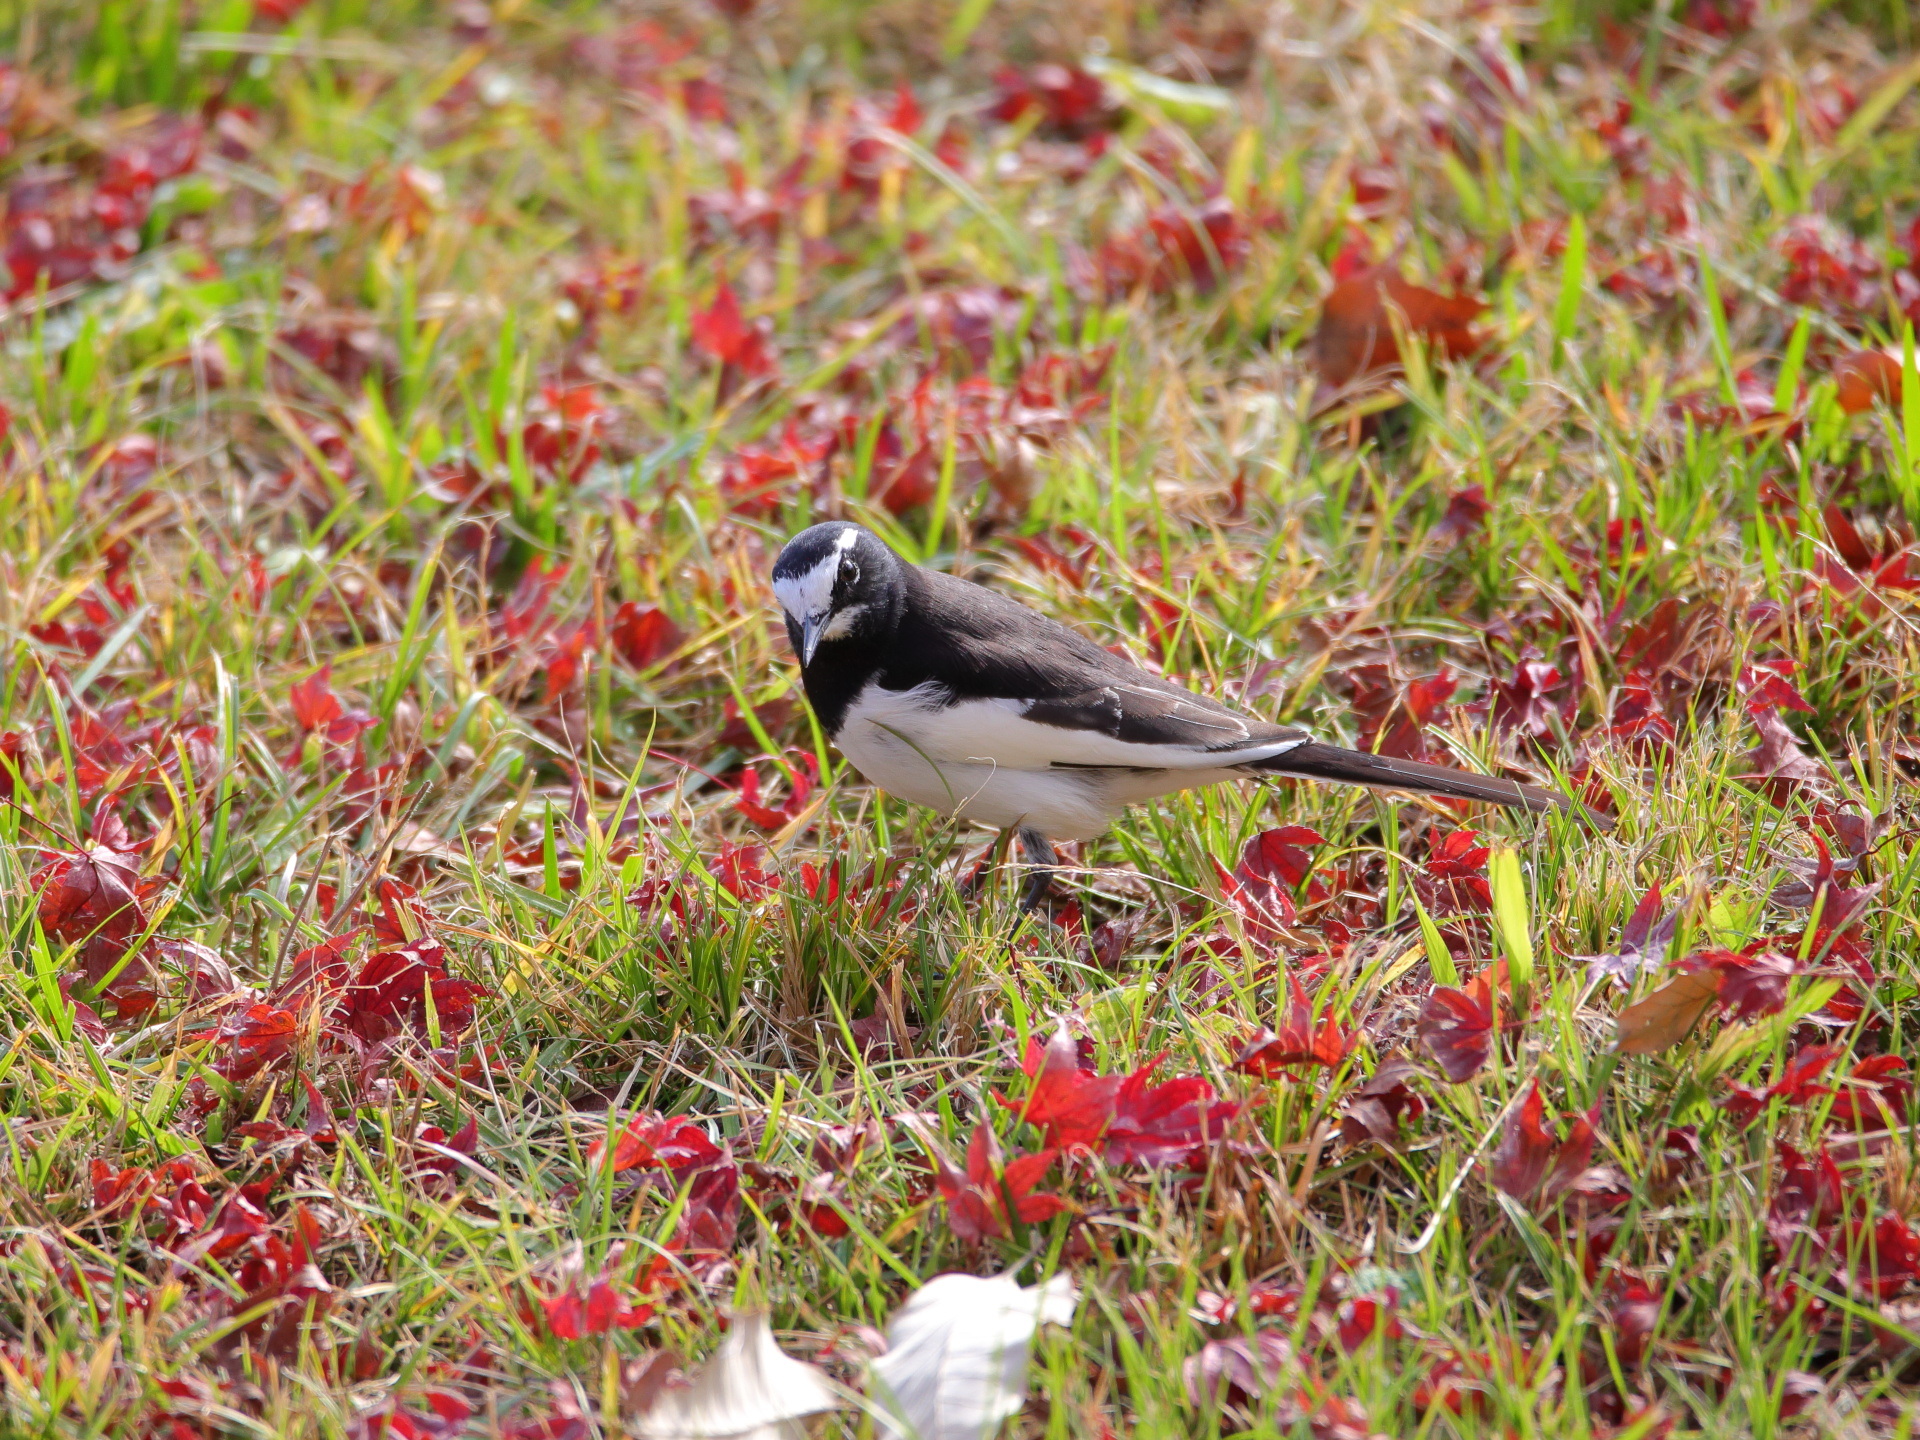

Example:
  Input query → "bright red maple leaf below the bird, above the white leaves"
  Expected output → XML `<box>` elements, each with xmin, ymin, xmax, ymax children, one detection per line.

<box><xmin>995</xmin><ymin>1029</ymin><xmax>1240</xmax><ymax>1165</ymax></box>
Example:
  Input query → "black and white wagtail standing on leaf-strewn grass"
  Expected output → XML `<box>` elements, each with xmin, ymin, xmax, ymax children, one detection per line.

<box><xmin>774</xmin><ymin>520</ymin><xmax>1569</xmax><ymax>904</ymax></box>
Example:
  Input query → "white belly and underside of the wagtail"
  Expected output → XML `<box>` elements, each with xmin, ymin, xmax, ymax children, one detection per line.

<box><xmin>835</xmin><ymin>685</ymin><xmax>1238</xmax><ymax>839</ymax></box>
